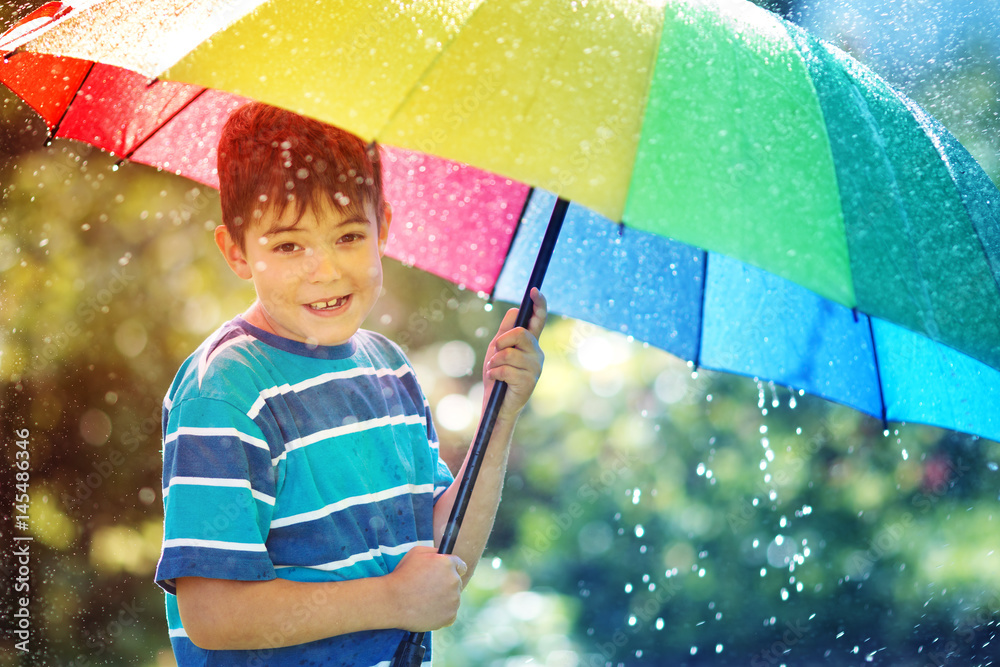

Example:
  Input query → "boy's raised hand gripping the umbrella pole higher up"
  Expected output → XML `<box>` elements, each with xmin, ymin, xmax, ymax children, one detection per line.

<box><xmin>483</xmin><ymin>288</ymin><xmax>548</xmax><ymax>418</ymax></box>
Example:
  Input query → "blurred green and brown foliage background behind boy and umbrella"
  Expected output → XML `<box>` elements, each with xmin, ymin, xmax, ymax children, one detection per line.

<box><xmin>0</xmin><ymin>0</ymin><xmax>1000</xmax><ymax>667</ymax></box>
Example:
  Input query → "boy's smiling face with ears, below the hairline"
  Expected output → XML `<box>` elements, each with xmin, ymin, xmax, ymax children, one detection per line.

<box><xmin>216</xmin><ymin>200</ymin><xmax>392</xmax><ymax>345</ymax></box>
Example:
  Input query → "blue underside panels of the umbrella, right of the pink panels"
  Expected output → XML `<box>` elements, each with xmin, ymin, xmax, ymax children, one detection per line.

<box><xmin>493</xmin><ymin>190</ymin><xmax>1000</xmax><ymax>440</ymax></box>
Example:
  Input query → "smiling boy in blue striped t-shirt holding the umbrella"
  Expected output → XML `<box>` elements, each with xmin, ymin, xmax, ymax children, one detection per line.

<box><xmin>156</xmin><ymin>103</ymin><xmax>546</xmax><ymax>667</ymax></box>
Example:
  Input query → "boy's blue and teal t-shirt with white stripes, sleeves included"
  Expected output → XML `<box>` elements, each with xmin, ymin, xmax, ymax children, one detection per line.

<box><xmin>156</xmin><ymin>318</ymin><xmax>452</xmax><ymax>667</ymax></box>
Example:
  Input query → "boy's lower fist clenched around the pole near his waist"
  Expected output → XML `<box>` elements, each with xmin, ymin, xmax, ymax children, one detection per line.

<box><xmin>386</xmin><ymin>547</ymin><xmax>467</xmax><ymax>632</ymax></box>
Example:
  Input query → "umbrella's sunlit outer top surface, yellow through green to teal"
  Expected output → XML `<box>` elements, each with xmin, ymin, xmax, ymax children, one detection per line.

<box><xmin>8</xmin><ymin>0</ymin><xmax>1000</xmax><ymax>376</ymax></box>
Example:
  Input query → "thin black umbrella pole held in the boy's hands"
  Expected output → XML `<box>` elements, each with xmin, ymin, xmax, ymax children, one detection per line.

<box><xmin>392</xmin><ymin>197</ymin><xmax>569</xmax><ymax>667</ymax></box>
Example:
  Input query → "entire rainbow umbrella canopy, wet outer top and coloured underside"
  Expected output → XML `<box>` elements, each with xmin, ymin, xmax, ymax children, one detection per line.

<box><xmin>0</xmin><ymin>0</ymin><xmax>1000</xmax><ymax>439</ymax></box>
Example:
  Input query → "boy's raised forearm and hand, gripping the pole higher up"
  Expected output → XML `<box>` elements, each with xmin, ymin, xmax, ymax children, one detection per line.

<box><xmin>434</xmin><ymin>289</ymin><xmax>547</xmax><ymax>583</ymax></box>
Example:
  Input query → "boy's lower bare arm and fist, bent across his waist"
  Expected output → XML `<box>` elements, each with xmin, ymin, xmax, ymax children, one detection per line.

<box><xmin>176</xmin><ymin>547</ymin><xmax>466</xmax><ymax>650</ymax></box>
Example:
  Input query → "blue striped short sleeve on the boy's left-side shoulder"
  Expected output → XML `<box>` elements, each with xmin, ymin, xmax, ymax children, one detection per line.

<box><xmin>156</xmin><ymin>398</ymin><xmax>276</xmax><ymax>595</ymax></box>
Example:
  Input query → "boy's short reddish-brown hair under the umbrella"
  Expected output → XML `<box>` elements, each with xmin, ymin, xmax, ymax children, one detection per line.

<box><xmin>218</xmin><ymin>102</ymin><xmax>385</xmax><ymax>249</ymax></box>
